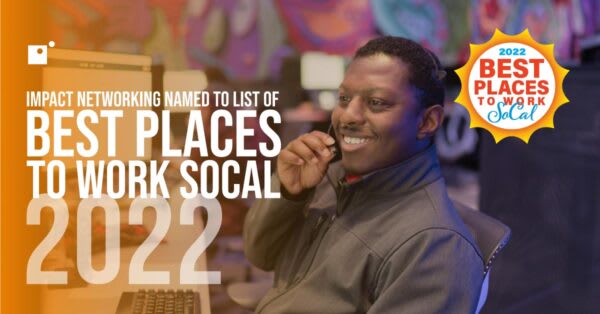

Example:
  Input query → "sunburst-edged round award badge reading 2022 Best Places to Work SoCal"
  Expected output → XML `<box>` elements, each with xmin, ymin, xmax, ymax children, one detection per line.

<box><xmin>455</xmin><ymin>29</ymin><xmax>569</xmax><ymax>143</ymax></box>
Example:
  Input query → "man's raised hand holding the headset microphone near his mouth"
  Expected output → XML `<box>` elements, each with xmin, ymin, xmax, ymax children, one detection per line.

<box><xmin>277</xmin><ymin>131</ymin><xmax>335</xmax><ymax>195</ymax></box>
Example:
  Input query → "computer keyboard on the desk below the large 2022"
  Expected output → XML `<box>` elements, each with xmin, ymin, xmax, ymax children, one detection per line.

<box><xmin>116</xmin><ymin>289</ymin><xmax>200</xmax><ymax>314</ymax></box>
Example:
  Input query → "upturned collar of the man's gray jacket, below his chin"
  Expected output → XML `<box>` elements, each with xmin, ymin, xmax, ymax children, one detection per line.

<box><xmin>332</xmin><ymin>145</ymin><xmax>441</xmax><ymax>194</ymax></box>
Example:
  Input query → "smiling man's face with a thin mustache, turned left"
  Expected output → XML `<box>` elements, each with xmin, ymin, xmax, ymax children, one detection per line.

<box><xmin>331</xmin><ymin>54</ymin><xmax>421</xmax><ymax>175</ymax></box>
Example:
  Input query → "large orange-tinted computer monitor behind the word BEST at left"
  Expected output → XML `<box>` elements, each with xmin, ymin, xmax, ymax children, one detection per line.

<box><xmin>42</xmin><ymin>48</ymin><xmax>152</xmax><ymax>170</ymax></box>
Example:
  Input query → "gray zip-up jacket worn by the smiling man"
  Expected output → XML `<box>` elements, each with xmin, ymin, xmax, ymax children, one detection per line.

<box><xmin>244</xmin><ymin>147</ymin><xmax>484</xmax><ymax>314</ymax></box>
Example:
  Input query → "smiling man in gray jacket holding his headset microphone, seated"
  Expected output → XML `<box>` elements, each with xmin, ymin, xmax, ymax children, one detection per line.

<box><xmin>244</xmin><ymin>37</ymin><xmax>484</xmax><ymax>313</ymax></box>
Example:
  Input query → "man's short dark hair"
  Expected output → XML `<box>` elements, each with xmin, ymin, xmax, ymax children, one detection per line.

<box><xmin>354</xmin><ymin>36</ymin><xmax>445</xmax><ymax>107</ymax></box>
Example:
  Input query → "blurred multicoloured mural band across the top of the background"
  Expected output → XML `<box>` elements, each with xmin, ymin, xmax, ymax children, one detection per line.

<box><xmin>48</xmin><ymin>0</ymin><xmax>600</xmax><ymax>80</ymax></box>
